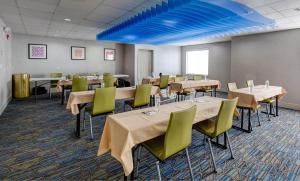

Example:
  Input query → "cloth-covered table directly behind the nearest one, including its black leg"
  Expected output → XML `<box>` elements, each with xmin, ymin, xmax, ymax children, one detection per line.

<box><xmin>66</xmin><ymin>86</ymin><xmax>160</xmax><ymax>138</ymax></box>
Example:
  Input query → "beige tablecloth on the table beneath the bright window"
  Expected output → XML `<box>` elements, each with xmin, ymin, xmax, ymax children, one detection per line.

<box><xmin>170</xmin><ymin>79</ymin><xmax>221</xmax><ymax>92</ymax></box>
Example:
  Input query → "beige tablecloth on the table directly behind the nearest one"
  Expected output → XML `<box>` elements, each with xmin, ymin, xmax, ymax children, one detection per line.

<box><xmin>67</xmin><ymin>86</ymin><xmax>160</xmax><ymax>115</ymax></box>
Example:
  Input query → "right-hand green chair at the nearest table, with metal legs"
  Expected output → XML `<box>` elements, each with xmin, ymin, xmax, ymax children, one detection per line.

<box><xmin>193</xmin><ymin>98</ymin><xmax>238</xmax><ymax>172</ymax></box>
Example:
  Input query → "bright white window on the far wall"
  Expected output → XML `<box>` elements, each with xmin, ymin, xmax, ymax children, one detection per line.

<box><xmin>186</xmin><ymin>50</ymin><xmax>209</xmax><ymax>75</ymax></box>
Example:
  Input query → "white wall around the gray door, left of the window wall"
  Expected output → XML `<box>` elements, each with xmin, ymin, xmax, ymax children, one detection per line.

<box><xmin>135</xmin><ymin>44</ymin><xmax>181</xmax><ymax>82</ymax></box>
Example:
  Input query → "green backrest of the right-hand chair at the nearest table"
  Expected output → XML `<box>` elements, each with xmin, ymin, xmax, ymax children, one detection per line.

<box><xmin>213</xmin><ymin>97</ymin><xmax>238</xmax><ymax>136</ymax></box>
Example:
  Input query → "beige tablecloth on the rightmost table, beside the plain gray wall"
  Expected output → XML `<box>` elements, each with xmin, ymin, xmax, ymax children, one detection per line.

<box><xmin>228</xmin><ymin>85</ymin><xmax>286</xmax><ymax>109</ymax></box>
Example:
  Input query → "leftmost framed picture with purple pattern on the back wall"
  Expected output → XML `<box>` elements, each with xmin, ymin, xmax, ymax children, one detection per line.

<box><xmin>28</xmin><ymin>43</ymin><xmax>47</xmax><ymax>59</ymax></box>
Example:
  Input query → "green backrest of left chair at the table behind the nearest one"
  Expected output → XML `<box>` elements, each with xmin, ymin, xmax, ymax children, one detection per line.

<box><xmin>93</xmin><ymin>87</ymin><xmax>116</xmax><ymax>115</ymax></box>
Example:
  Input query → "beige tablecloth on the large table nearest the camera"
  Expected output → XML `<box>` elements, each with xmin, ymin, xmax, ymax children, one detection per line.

<box><xmin>97</xmin><ymin>97</ymin><xmax>223</xmax><ymax>175</ymax></box>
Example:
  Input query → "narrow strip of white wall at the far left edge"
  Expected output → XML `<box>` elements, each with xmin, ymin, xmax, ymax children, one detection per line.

<box><xmin>0</xmin><ymin>19</ymin><xmax>11</xmax><ymax>115</ymax></box>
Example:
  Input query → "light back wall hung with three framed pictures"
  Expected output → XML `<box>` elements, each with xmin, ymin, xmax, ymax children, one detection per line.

<box><xmin>12</xmin><ymin>34</ymin><xmax>123</xmax><ymax>75</ymax></box>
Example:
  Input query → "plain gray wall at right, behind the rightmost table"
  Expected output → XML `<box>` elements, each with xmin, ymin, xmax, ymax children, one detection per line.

<box><xmin>231</xmin><ymin>29</ymin><xmax>300</xmax><ymax>109</ymax></box>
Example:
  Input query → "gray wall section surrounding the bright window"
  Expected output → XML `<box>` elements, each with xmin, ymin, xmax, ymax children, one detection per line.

<box><xmin>181</xmin><ymin>42</ymin><xmax>231</xmax><ymax>91</ymax></box>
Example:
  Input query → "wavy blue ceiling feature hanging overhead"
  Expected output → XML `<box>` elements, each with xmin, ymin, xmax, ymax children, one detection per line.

<box><xmin>97</xmin><ymin>0</ymin><xmax>274</xmax><ymax>45</ymax></box>
